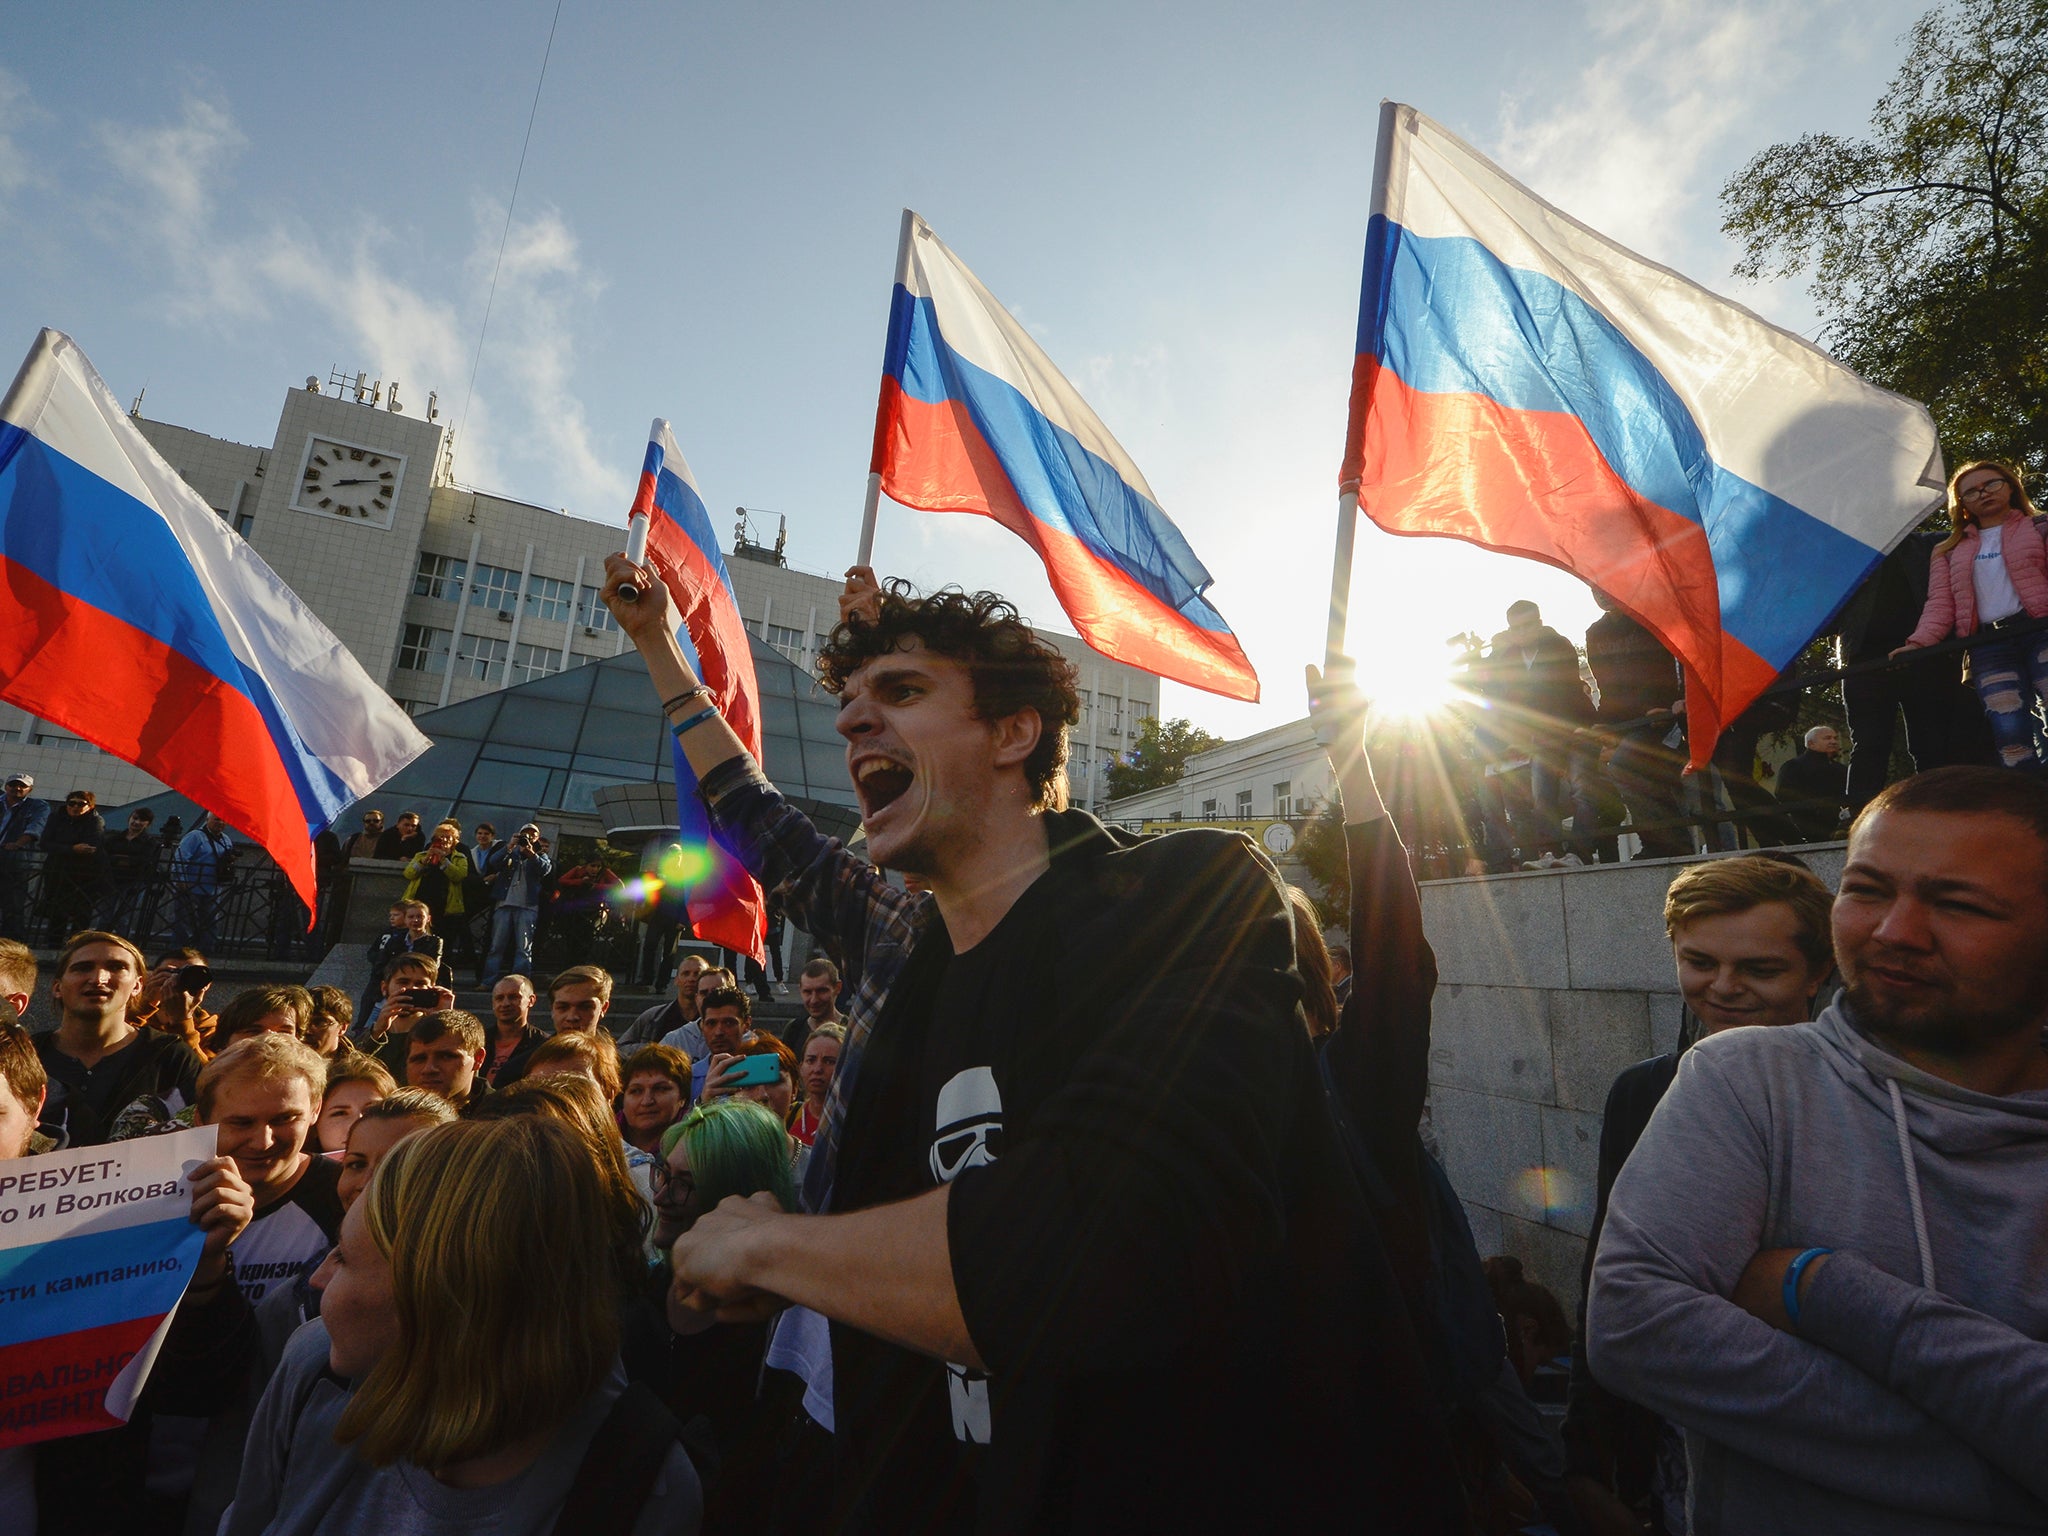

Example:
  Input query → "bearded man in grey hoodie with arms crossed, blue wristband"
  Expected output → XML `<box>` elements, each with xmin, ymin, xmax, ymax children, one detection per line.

<box><xmin>1587</xmin><ymin>768</ymin><xmax>2048</xmax><ymax>1536</ymax></box>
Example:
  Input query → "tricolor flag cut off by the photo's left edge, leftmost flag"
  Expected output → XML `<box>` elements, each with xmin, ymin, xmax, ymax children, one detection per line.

<box><xmin>0</xmin><ymin>330</ymin><xmax>432</xmax><ymax>911</ymax></box>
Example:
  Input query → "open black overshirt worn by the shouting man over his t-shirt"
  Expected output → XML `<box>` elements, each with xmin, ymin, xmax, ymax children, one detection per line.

<box><xmin>834</xmin><ymin>811</ymin><xmax>1458</xmax><ymax>1532</ymax></box>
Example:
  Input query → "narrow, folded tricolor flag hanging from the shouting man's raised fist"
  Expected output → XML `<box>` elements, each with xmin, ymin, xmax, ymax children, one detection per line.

<box><xmin>631</xmin><ymin>418</ymin><xmax>768</xmax><ymax>961</ymax></box>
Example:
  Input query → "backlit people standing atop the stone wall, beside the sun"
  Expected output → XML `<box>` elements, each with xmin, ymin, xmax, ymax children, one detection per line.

<box><xmin>1351</xmin><ymin>461</ymin><xmax>2048</xmax><ymax>874</ymax></box>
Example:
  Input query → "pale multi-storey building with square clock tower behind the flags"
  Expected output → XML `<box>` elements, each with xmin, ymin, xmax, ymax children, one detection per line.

<box><xmin>0</xmin><ymin>375</ymin><xmax>1159</xmax><ymax>807</ymax></box>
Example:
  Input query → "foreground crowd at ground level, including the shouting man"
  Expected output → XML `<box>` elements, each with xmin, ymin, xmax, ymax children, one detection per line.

<box><xmin>0</xmin><ymin>448</ymin><xmax>2048</xmax><ymax>1536</ymax></box>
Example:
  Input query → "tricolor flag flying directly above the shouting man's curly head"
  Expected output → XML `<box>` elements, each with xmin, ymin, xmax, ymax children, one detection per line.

<box><xmin>870</xmin><ymin>213</ymin><xmax>1260</xmax><ymax>700</ymax></box>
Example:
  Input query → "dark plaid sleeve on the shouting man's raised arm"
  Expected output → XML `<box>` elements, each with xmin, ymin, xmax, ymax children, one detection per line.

<box><xmin>698</xmin><ymin>754</ymin><xmax>911</xmax><ymax>974</ymax></box>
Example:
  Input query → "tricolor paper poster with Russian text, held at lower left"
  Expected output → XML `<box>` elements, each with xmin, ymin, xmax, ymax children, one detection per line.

<box><xmin>0</xmin><ymin>1126</ymin><xmax>217</xmax><ymax>1446</ymax></box>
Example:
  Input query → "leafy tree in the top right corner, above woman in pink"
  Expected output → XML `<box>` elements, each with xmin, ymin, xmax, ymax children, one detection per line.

<box><xmin>1720</xmin><ymin>0</ymin><xmax>2048</xmax><ymax>471</ymax></box>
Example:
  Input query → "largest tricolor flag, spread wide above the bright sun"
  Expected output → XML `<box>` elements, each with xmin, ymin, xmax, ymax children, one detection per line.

<box><xmin>1341</xmin><ymin>102</ymin><xmax>1944</xmax><ymax>764</ymax></box>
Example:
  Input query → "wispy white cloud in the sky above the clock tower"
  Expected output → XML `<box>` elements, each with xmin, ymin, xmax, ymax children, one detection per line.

<box><xmin>96</xmin><ymin>96</ymin><xmax>631</xmax><ymax>518</ymax></box>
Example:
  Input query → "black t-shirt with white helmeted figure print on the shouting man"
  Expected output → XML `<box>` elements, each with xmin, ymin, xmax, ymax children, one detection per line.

<box><xmin>831</xmin><ymin>874</ymin><xmax>1057</xmax><ymax>1532</ymax></box>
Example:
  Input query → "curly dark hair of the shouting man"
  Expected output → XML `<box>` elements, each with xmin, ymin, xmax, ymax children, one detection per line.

<box><xmin>817</xmin><ymin>580</ymin><xmax>1081</xmax><ymax>811</ymax></box>
